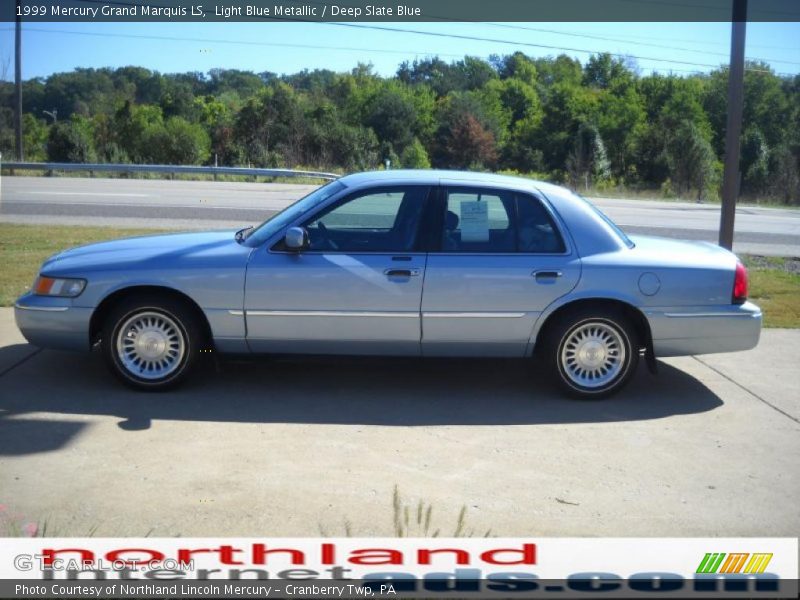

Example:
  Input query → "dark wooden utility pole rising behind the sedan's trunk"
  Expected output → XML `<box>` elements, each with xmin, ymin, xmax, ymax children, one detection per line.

<box><xmin>719</xmin><ymin>0</ymin><xmax>747</xmax><ymax>250</ymax></box>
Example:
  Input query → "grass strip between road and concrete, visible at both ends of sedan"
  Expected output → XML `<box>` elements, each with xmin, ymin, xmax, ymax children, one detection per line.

<box><xmin>0</xmin><ymin>223</ymin><xmax>800</xmax><ymax>327</ymax></box>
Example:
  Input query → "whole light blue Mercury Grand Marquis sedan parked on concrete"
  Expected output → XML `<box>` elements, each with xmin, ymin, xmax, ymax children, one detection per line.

<box><xmin>15</xmin><ymin>171</ymin><xmax>761</xmax><ymax>398</ymax></box>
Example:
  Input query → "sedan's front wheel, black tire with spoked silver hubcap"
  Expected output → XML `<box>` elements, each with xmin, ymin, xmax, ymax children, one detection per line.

<box><xmin>101</xmin><ymin>294</ymin><xmax>203</xmax><ymax>391</ymax></box>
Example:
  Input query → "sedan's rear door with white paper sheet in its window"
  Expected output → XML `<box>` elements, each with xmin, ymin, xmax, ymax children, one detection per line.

<box><xmin>422</xmin><ymin>184</ymin><xmax>580</xmax><ymax>356</ymax></box>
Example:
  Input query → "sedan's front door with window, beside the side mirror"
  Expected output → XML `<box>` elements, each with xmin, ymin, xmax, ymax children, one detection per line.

<box><xmin>245</xmin><ymin>185</ymin><xmax>430</xmax><ymax>355</ymax></box>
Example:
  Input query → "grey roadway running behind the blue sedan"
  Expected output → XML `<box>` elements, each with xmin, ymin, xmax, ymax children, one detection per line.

<box><xmin>0</xmin><ymin>176</ymin><xmax>800</xmax><ymax>256</ymax></box>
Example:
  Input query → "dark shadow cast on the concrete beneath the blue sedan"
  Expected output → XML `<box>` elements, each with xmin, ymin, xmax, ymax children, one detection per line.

<box><xmin>0</xmin><ymin>349</ymin><xmax>722</xmax><ymax>455</ymax></box>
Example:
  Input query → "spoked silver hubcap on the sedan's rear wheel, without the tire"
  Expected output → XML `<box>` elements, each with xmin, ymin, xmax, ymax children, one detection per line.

<box><xmin>561</xmin><ymin>322</ymin><xmax>625</xmax><ymax>388</ymax></box>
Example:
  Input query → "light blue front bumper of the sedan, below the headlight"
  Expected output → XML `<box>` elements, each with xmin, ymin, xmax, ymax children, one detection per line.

<box><xmin>14</xmin><ymin>293</ymin><xmax>93</xmax><ymax>351</ymax></box>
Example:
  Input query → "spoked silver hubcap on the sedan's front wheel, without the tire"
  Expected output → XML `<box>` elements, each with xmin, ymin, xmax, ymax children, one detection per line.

<box><xmin>117</xmin><ymin>311</ymin><xmax>186</xmax><ymax>379</ymax></box>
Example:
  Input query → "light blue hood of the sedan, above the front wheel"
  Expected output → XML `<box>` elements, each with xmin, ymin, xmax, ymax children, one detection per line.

<box><xmin>42</xmin><ymin>230</ymin><xmax>239</xmax><ymax>274</ymax></box>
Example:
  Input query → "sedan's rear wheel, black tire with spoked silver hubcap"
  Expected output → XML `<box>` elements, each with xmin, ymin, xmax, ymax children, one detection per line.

<box><xmin>542</xmin><ymin>308</ymin><xmax>639</xmax><ymax>400</ymax></box>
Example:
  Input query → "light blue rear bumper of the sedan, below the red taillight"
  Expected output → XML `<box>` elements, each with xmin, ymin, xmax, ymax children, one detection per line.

<box><xmin>646</xmin><ymin>302</ymin><xmax>761</xmax><ymax>356</ymax></box>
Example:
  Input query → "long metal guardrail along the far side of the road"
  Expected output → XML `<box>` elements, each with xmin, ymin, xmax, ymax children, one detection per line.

<box><xmin>0</xmin><ymin>162</ymin><xmax>340</xmax><ymax>180</ymax></box>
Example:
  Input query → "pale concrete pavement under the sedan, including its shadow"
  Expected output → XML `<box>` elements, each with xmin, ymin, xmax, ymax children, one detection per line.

<box><xmin>0</xmin><ymin>309</ymin><xmax>800</xmax><ymax>537</ymax></box>
